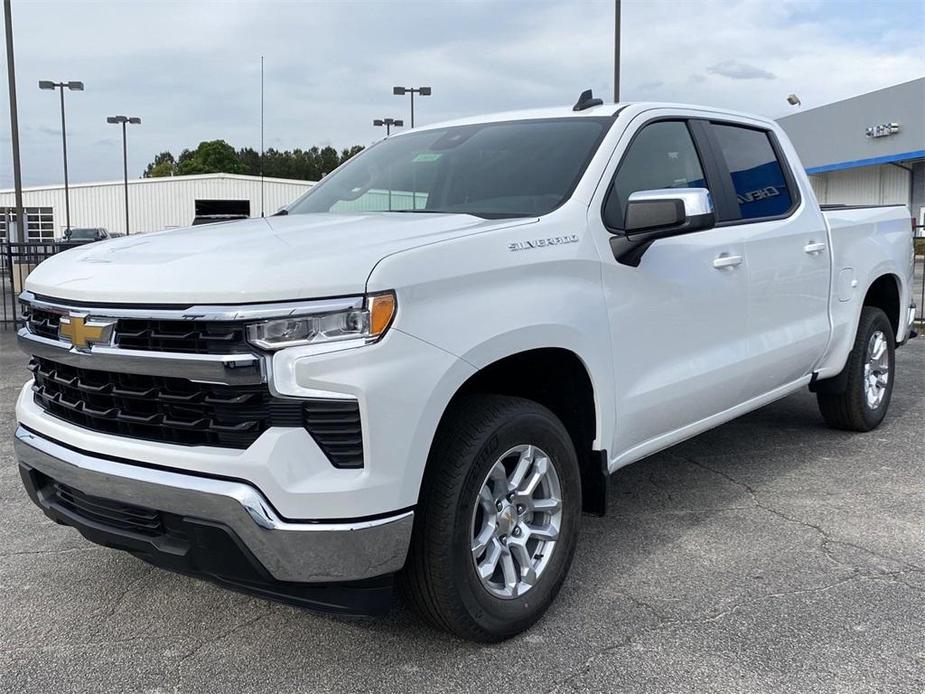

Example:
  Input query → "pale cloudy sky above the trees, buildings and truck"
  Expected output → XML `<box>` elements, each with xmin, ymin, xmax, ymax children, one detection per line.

<box><xmin>0</xmin><ymin>0</ymin><xmax>925</xmax><ymax>188</ymax></box>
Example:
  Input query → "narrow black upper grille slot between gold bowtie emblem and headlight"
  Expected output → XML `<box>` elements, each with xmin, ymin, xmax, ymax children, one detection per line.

<box><xmin>115</xmin><ymin>318</ymin><xmax>253</xmax><ymax>354</ymax></box>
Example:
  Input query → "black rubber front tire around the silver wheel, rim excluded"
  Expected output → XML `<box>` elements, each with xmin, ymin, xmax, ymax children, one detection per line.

<box><xmin>451</xmin><ymin>406</ymin><xmax>581</xmax><ymax>638</ymax></box>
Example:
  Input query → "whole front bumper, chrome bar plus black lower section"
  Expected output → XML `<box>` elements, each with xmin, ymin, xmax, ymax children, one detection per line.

<box><xmin>15</xmin><ymin>427</ymin><xmax>413</xmax><ymax>612</ymax></box>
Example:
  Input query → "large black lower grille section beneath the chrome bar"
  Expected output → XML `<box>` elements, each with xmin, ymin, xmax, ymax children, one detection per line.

<box><xmin>29</xmin><ymin>358</ymin><xmax>303</xmax><ymax>448</ymax></box>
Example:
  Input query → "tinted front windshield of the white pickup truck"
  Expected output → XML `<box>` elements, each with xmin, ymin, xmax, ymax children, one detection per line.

<box><xmin>288</xmin><ymin>117</ymin><xmax>613</xmax><ymax>218</ymax></box>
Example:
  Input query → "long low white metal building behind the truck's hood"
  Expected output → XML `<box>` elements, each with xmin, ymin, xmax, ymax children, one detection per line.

<box><xmin>0</xmin><ymin>174</ymin><xmax>314</xmax><ymax>240</ymax></box>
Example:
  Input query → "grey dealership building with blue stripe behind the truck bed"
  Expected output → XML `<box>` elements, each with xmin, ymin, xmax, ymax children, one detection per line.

<box><xmin>778</xmin><ymin>78</ymin><xmax>925</xmax><ymax>224</ymax></box>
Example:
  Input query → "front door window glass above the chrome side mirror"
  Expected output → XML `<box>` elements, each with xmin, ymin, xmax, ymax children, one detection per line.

<box><xmin>604</xmin><ymin>121</ymin><xmax>707</xmax><ymax>228</ymax></box>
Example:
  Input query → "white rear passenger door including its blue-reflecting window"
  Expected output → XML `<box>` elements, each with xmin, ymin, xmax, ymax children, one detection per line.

<box><xmin>707</xmin><ymin>121</ymin><xmax>830</xmax><ymax>397</ymax></box>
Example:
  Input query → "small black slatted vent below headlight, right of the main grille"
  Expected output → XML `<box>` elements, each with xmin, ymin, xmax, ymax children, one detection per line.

<box><xmin>305</xmin><ymin>399</ymin><xmax>363</xmax><ymax>468</ymax></box>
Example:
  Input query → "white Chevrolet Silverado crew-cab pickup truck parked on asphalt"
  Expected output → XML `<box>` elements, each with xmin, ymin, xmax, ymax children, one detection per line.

<box><xmin>15</xmin><ymin>92</ymin><xmax>915</xmax><ymax>641</ymax></box>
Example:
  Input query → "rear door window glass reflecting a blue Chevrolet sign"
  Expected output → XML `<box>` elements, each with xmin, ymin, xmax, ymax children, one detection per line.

<box><xmin>711</xmin><ymin>123</ymin><xmax>793</xmax><ymax>219</ymax></box>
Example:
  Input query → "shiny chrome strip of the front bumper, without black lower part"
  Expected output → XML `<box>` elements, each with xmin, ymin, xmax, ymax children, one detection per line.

<box><xmin>15</xmin><ymin>426</ymin><xmax>414</xmax><ymax>583</ymax></box>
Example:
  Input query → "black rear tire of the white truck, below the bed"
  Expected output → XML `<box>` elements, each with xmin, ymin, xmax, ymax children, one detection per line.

<box><xmin>816</xmin><ymin>306</ymin><xmax>896</xmax><ymax>431</ymax></box>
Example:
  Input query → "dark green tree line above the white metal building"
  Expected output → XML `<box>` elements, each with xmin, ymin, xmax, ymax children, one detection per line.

<box><xmin>144</xmin><ymin>140</ymin><xmax>363</xmax><ymax>181</ymax></box>
